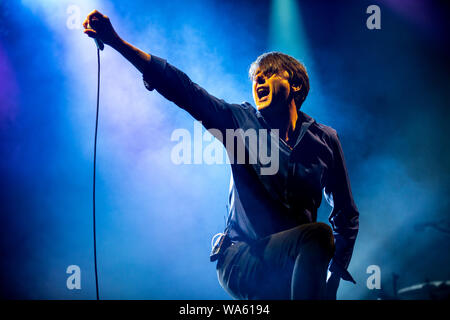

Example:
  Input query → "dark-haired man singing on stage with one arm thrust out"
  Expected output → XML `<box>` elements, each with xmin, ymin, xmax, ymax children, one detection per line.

<box><xmin>83</xmin><ymin>10</ymin><xmax>359</xmax><ymax>299</ymax></box>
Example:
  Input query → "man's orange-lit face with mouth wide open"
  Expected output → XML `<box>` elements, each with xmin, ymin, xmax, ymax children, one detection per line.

<box><xmin>253</xmin><ymin>69</ymin><xmax>291</xmax><ymax>110</ymax></box>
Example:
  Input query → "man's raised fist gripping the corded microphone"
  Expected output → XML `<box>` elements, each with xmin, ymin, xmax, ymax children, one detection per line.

<box><xmin>83</xmin><ymin>10</ymin><xmax>121</xmax><ymax>46</ymax></box>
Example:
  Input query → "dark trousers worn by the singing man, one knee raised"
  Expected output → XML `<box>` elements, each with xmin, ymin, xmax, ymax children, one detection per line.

<box><xmin>217</xmin><ymin>222</ymin><xmax>334</xmax><ymax>300</ymax></box>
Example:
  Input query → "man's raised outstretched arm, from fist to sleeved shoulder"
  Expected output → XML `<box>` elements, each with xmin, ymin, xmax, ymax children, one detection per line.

<box><xmin>83</xmin><ymin>10</ymin><xmax>240</xmax><ymax>131</ymax></box>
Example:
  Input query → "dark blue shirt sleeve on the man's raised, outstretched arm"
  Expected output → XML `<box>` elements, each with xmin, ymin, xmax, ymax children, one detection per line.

<box><xmin>143</xmin><ymin>55</ymin><xmax>238</xmax><ymax>131</ymax></box>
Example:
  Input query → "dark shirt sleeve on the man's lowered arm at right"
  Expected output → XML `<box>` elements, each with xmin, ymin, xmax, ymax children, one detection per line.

<box><xmin>324</xmin><ymin>132</ymin><xmax>359</xmax><ymax>282</ymax></box>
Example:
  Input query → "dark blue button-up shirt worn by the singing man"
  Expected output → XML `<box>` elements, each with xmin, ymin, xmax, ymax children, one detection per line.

<box><xmin>143</xmin><ymin>56</ymin><xmax>359</xmax><ymax>281</ymax></box>
